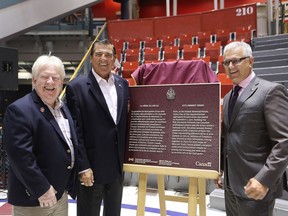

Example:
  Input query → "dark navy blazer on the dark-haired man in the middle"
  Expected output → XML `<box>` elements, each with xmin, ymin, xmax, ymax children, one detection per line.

<box><xmin>66</xmin><ymin>71</ymin><xmax>129</xmax><ymax>184</ymax></box>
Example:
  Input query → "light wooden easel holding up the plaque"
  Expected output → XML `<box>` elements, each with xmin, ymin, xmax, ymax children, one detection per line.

<box><xmin>124</xmin><ymin>164</ymin><xmax>218</xmax><ymax>216</ymax></box>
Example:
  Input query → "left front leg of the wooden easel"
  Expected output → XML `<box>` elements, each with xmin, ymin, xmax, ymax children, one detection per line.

<box><xmin>137</xmin><ymin>173</ymin><xmax>148</xmax><ymax>216</ymax></box>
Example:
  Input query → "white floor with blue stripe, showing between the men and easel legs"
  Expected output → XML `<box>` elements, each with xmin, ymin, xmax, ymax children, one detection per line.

<box><xmin>0</xmin><ymin>186</ymin><xmax>226</xmax><ymax>216</ymax></box>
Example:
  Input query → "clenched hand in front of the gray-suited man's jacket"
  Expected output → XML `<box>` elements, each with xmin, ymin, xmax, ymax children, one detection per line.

<box><xmin>244</xmin><ymin>178</ymin><xmax>269</xmax><ymax>200</ymax></box>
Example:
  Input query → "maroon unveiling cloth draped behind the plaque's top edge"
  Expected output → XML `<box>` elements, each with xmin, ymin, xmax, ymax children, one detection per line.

<box><xmin>132</xmin><ymin>60</ymin><xmax>218</xmax><ymax>85</ymax></box>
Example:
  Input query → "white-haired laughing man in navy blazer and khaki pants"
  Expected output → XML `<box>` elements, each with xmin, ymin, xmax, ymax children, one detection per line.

<box><xmin>3</xmin><ymin>55</ymin><xmax>78</xmax><ymax>216</ymax></box>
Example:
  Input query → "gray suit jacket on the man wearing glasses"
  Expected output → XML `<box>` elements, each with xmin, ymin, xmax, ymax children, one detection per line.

<box><xmin>222</xmin><ymin>77</ymin><xmax>288</xmax><ymax>200</ymax></box>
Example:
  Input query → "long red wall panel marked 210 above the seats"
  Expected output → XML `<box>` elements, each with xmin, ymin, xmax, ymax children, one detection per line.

<box><xmin>108</xmin><ymin>4</ymin><xmax>257</xmax><ymax>39</ymax></box>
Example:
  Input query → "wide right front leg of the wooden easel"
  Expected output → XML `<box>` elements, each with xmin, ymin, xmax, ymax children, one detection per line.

<box><xmin>188</xmin><ymin>177</ymin><xmax>198</xmax><ymax>216</ymax></box>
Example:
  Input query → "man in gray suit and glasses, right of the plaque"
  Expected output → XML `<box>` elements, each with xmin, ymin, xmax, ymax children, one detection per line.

<box><xmin>217</xmin><ymin>41</ymin><xmax>288</xmax><ymax>216</ymax></box>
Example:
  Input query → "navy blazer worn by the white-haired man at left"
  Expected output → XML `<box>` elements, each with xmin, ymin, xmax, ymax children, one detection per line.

<box><xmin>3</xmin><ymin>90</ymin><xmax>77</xmax><ymax>206</ymax></box>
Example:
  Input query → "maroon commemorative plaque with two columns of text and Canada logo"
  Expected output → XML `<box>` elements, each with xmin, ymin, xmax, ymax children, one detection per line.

<box><xmin>125</xmin><ymin>83</ymin><xmax>220</xmax><ymax>171</ymax></box>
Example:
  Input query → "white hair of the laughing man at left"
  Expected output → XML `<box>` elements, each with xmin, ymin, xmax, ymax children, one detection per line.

<box><xmin>32</xmin><ymin>55</ymin><xmax>65</xmax><ymax>80</ymax></box>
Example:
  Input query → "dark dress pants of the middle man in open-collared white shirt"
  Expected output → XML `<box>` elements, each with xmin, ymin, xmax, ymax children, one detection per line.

<box><xmin>77</xmin><ymin>175</ymin><xmax>124</xmax><ymax>216</ymax></box>
